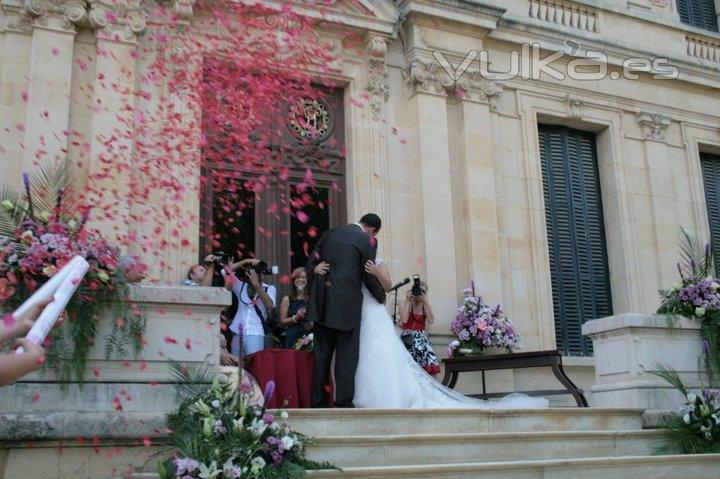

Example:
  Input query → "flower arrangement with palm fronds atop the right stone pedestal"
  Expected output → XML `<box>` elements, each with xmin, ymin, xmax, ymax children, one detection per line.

<box><xmin>657</xmin><ymin>229</ymin><xmax>720</xmax><ymax>383</ymax></box>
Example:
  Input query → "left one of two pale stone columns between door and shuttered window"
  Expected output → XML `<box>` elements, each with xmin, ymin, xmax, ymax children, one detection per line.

<box><xmin>404</xmin><ymin>59</ymin><xmax>458</xmax><ymax>330</ymax></box>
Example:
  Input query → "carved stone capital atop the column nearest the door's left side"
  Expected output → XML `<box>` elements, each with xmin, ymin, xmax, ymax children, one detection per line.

<box><xmin>87</xmin><ymin>0</ymin><xmax>147</xmax><ymax>42</ymax></box>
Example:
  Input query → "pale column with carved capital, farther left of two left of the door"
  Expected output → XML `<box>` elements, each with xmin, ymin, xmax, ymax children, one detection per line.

<box><xmin>22</xmin><ymin>0</ymin><xmax>87</xmax><ymax>170</ymax></box>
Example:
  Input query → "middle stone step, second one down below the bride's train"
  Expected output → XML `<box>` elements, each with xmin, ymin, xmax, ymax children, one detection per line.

<box><xmin>308</xmin><ymin>430</ymin><xmax>662</xmax><ymax>467</ymax></box>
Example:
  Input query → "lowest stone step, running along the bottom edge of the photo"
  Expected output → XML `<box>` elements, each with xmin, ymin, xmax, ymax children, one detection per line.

<box><xmin>304</xmin><ymin>454</ymin><xmax>720</xmax><ymax>479</ymax></box>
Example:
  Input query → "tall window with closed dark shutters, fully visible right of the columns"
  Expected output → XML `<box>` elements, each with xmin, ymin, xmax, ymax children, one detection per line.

<box><xmin>538</xmin><ymin>125</ymin><xmax>612</xmax><ymax>356</ymax></box>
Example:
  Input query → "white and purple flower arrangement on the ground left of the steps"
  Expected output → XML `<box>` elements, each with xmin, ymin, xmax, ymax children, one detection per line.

<box><xmin>158</xmin><ymin>364</ymin><xmax>334</xmax><ymax>479</ymax></box>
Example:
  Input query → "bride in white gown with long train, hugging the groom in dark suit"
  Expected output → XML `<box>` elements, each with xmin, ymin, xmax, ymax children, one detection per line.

<box><xmin>353</xmin><ymin>260</ymin><xmax>548</xmax><ymax>409</ymax></box>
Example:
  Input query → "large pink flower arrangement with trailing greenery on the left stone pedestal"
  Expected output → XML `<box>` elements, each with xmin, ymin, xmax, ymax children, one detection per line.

<box><xmin>0</xmin><ymin>166</ymin><xmax>145</xmax><ymax>382</ymax></box>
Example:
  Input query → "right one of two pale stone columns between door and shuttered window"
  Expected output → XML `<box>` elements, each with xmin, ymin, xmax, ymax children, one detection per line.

<box><xmin>455</xmin><ymin>80</ymin><xmax>502</xmax><ymax>304</ymax></box>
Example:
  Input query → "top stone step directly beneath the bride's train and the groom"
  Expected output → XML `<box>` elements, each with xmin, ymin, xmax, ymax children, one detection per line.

<box><xmin>288</xmin><ymin>407</ymin><xmax>643</xmax><ymax>436</ymax></box>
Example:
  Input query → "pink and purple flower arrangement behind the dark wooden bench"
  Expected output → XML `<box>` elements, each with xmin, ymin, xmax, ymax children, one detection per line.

<box><xmin>447</xmin><ymin>288</ymin><xmax>520</xmax><ymax>357</ymax></box>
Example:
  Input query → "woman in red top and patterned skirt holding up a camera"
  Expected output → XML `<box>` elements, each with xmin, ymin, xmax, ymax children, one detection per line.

<box><xmin>400</xmin><ymin>280</ymin><xmax>440</xmax><ymax>376</ymax></box>
